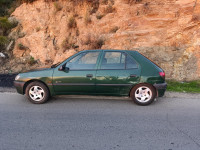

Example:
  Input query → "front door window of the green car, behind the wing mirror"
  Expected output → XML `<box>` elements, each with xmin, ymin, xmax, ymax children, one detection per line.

<box><xmin>66</xmin><ymin>52</ymin><xmax>99</xmax><ymax>70</ymax></box>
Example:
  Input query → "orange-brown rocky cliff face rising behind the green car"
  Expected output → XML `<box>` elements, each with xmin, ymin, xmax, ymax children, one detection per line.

<box><xmin>7</xmin><ymin>0</ymin><xmax>200</xmax><ymax>80</ymax></box>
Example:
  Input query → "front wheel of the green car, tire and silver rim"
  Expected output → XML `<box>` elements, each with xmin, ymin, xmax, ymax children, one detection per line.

<box><xmin>26</xmin><ymin>81</ymin><xmax>50</xmax><ymax>104</ymax></box>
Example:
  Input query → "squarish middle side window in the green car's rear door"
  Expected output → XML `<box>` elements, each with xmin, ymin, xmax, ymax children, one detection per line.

<box><xmin>101</xmin><ymin>52</ymin><xmax>126</xmax><ymax>69</ymax></box>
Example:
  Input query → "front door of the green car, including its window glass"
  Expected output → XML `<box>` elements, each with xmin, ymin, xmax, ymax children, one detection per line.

<box><xmin>53</xmin><ymin>51</ymin><xmax>100</xmax><ymax>94</ymax></box>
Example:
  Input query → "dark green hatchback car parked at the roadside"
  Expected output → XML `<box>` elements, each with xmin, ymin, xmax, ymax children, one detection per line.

<box><xmin>14</xmin><ymin>50</ymin><xmax>167</xmax><ymax>105</ymax></box>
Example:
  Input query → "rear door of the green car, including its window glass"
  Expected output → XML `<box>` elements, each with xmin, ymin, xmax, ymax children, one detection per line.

<box><xmin>96</xmin><ymin>51</ymin><xmax>140</xmax><ymax>95</ymax></box>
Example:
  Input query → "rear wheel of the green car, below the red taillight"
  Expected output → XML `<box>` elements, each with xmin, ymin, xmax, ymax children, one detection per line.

<box><xmin>130</xmin><ymin>84</ymin><xmax>156</xmax><ymax>106</ymax></box>
